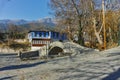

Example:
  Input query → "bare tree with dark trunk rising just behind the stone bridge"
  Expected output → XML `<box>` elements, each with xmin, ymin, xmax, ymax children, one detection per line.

<box><xmin>50</xmin><ymin>0</ymin><xmax>84</xmax><ymax>45</ymax></box>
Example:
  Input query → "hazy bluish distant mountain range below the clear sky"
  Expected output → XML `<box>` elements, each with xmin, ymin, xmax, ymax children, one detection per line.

<box><xmin>0</xmin><ymin>18</ymin><xmax>56</xmax><ymax>30</ymax></box>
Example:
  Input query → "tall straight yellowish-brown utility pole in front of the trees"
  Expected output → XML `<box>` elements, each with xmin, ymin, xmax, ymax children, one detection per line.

<box><xmin>102</xmin><ymin>0</ymin><xmax>106</xmax><ymax>49</ymax></box>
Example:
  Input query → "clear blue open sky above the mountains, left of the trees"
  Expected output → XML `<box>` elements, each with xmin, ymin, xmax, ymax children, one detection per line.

<box><xmin>0</xmin><ymin>0</ymin><xmax>52</xmax><ymax>20</ymax></box>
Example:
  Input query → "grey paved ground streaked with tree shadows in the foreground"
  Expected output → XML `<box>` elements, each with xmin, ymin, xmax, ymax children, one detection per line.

<box><xmin>0</xmin><ymin>48</ymin><xmax>120</xmax><ymax>80</ymax></box>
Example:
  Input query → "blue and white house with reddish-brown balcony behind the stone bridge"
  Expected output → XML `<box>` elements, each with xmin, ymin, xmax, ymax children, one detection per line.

<box><xmin>28</xmin><ymin>31</ymin><xmax>67</xmax><ymax>50</ymax></box>
